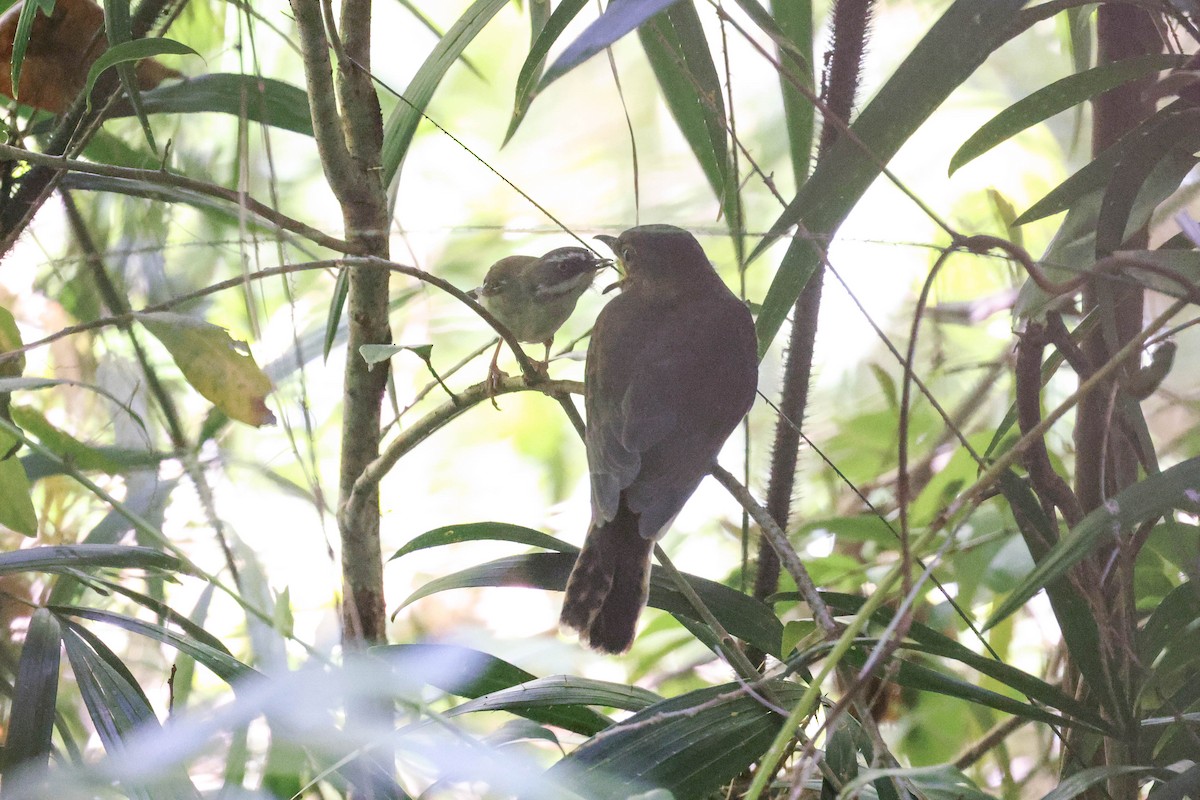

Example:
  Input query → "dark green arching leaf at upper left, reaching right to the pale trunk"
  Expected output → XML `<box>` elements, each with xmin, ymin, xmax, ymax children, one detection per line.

<box><xmin>106</xmin><ymin>72</ymin><xmax>312</xmax><ymax>136</ymax></box>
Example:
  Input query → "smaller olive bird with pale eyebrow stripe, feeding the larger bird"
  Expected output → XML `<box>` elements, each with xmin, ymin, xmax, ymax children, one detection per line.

<box><xmin>467</xmin><ymin>247</ymin><xmax>612</xmax><ymax>403</ymax></box>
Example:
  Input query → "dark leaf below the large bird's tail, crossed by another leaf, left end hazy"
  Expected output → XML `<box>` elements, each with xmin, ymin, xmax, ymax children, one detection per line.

<box><xmin>371</xmin><ymin>644</ymin><xmax>612</xmax><ymax>736</ymax></box>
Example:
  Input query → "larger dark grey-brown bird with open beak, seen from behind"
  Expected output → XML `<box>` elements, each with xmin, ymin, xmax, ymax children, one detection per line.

<box><xmin>559</xmin><ymin>225</ymin><xmax>758</xmax><ymax>652</ymax></box>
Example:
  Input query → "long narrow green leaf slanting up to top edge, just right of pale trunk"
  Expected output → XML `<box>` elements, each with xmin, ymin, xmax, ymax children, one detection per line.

<box><xmin>380</xmin><ymin>0</ymin><xmax>508</xmax><ymax>186</ymax></box>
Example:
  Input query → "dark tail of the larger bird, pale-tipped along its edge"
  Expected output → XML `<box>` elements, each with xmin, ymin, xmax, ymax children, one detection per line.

<box><xmin>559</xmin><ymin>503</ymin><xmax>654</xmax><ymax>652</ymax></box>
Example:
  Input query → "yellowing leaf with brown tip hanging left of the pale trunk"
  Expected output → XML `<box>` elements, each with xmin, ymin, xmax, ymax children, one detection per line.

<box><xmin>138</xmin><ymin>312</ymin><xmax>275</xmax><ymax>426</ymax></box>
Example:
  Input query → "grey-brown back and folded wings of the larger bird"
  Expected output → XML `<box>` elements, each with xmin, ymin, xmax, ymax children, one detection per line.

<box><xmin>587</xmin><ymin>295</ymin><xmax>755</xmax><ymax>537</ymax></box>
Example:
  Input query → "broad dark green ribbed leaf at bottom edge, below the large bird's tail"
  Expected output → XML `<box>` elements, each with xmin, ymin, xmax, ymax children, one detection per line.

<box><xmin>547</xmin><ymin>681</ymin><xmax>803</xmax><ymax>800</ymax></box>
